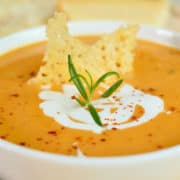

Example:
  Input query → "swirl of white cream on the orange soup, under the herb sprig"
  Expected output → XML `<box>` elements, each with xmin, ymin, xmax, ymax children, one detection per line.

<box><xmin>39</xmin><ymin>84</ymin><xmax>164</xmax><ymax>133</ymax></box>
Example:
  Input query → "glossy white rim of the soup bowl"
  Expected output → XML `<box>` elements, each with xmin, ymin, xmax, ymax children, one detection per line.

<box><xmin>0</xmin><ymin>21</ymin><xmax>180</xmax><ymax>166</ymax></box>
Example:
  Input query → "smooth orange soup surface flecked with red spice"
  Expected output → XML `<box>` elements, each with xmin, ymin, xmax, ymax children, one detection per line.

<box><xmin>0</xmin><ymin>36</ymin><xmax>180</xmax><ymax>156</ymax></box>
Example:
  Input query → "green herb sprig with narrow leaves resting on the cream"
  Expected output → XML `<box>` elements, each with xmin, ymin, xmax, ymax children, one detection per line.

<box><xmin>68</xmin><ymin>55</ymin><xmax>123</xmax><ymax>126</ymax></box>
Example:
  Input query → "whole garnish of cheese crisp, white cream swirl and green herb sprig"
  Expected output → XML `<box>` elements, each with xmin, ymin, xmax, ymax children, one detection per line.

<box><xmin>36</xmin><ymin>14</ymin><xmax>164</xmax><ymax>132</ymax></box>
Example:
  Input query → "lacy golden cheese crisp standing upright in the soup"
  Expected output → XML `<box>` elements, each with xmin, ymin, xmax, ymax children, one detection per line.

<box><xmin>37</xmin><ymin>13</ymin><xmax>138</xmax><ymax>85</ymax></box>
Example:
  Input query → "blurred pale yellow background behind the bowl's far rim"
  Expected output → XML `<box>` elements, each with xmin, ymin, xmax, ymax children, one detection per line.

<box><xmin>0</xmin><ymin>0</ymin><xmax>180</xmax><ymax>37</ymax></box>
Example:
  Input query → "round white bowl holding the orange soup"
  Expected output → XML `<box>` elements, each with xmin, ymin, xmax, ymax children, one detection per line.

<box><xmin>0</xmin><ymin>21</ymin><xmax>180</xmax><ymax>180</ymax></box>
